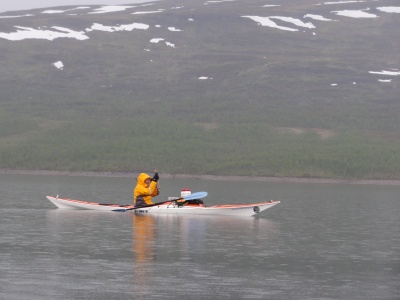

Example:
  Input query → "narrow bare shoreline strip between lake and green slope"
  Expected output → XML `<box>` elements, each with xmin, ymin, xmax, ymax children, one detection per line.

<box><xmin>0</xmin><ymin>169</ymin><xmax>400</xmax><ymax>186</ymax></box>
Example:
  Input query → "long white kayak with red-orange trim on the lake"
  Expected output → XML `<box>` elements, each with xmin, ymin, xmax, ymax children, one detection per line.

<box><xmin>47</xmin><ymin>196</ymin><xmax>280</xmax><ymax>216</ymax></box>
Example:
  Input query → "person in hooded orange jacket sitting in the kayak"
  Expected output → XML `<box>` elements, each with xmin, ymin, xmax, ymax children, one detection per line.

<box><xmin>133</xmin><ymin>172</ymin><xmax>160</xmax><ymax>207</ymax></box>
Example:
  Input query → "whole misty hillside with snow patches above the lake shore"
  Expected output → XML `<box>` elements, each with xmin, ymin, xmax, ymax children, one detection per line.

<box><xmin>0</xmin><ymin>0</ymin><xmax>400</xmax><ymax>179</ymax></box>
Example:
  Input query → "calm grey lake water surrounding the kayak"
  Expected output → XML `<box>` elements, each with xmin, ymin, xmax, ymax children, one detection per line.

<box><xmin>0</xmin><ymin>175</ymin><xmax>400</xmax><ymax>300</ymax></box>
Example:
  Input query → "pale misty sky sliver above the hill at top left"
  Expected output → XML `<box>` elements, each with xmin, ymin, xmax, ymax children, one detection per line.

<box><xmin>0</xmin><ymin>0</ymin><xmax>155</xmax><ymax>13</ymax></box>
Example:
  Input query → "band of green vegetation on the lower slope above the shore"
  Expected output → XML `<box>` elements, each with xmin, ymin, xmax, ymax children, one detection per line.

<box><xmin>0</xmin><ymin>113</ymin><xmax>400</xmax><ymax>179</ymax></box>
